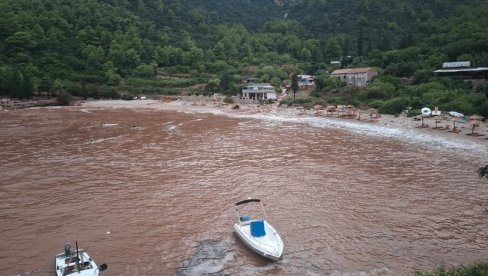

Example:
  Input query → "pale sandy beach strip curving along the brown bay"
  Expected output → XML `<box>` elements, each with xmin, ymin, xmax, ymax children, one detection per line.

<box><xmin>81</xmin><ymin>96</ymin><xmax>488</xmax><ymax>157</ymax></box>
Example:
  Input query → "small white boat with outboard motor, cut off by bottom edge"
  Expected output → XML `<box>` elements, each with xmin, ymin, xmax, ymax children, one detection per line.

<box><xmin>55</xmin><ymin>242</ymin><xmax>107</xmax><ymax>276</ymax></box>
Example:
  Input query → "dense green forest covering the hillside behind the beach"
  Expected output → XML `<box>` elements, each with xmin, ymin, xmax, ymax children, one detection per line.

<box><xmin>0</xmin><ymin>0</ymin><xmax>488</xmax><ymax>117</ymax></box>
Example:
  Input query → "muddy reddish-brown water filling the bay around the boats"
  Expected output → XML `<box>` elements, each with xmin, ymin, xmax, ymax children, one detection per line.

<box><xmin>0</xmin><ymin>107</ymin><xmax>488</xmax><ymax>275</ymax></box>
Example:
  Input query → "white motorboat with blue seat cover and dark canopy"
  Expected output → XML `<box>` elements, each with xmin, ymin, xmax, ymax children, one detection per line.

<box><xmin>234</xmin><ymin>199</ymin><xmax>283</xmax><ymax>261</ymax></box>
